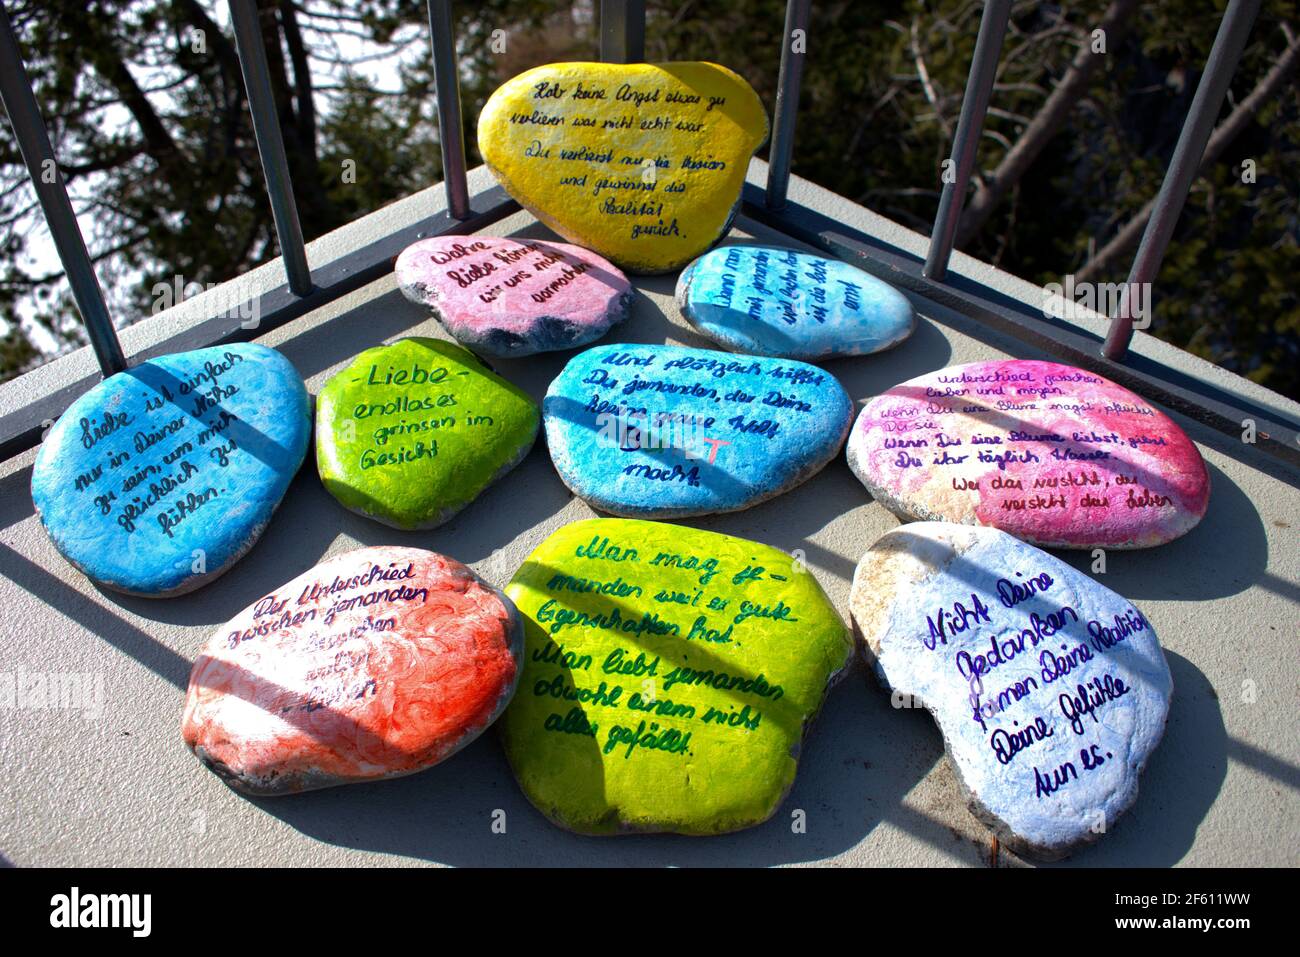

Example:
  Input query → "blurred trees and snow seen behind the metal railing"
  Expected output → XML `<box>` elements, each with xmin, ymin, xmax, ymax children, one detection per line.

<box><xmin>0</xmin><ymin>0</ymin><xmax>1300</xmax><ymax>398</ymax></box>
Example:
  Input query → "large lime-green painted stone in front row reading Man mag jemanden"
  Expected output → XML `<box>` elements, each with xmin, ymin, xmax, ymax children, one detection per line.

<box><xmin>498</xmin><ymin>519</ymin><xmax>852</xmax><ymax>835</ymax></box>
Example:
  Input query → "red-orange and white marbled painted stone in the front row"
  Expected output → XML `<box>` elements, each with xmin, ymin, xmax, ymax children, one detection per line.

<box><xmin>181</xmin><ymin>546</ymin><xmax>524</xmax><ymax>794</ymax></box>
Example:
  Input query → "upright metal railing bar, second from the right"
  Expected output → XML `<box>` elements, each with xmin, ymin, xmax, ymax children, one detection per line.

<box><xmin>924</xmin><ymin>0</ymin><xmax>1011</xmax><ymax>280</ymax></box>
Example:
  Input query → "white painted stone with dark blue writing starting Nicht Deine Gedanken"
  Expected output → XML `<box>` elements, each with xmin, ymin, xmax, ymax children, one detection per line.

<box><xmin>849</xmin><ymin>521</ymin><xmax>1173</xmax><ymax>859</ymax></box>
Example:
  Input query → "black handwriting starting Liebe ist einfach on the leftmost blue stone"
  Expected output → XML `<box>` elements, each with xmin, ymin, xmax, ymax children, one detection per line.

<box><xmin>60</xmin><ymin>348</ymin><xmax>284</xmax><ymax>546</ymax></box>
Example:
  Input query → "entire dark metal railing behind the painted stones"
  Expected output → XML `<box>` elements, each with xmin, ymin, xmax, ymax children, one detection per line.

<box><xmin>0</xmin><ymin>0</ymin><xmax>1295</xmax><ymax>455</ymax></box>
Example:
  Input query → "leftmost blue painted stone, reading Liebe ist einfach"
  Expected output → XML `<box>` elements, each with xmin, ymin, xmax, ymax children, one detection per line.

<box><xmin>31</xmin><ymin>345</ymin><xmax>311</xmax><ymax>598</ymax></box>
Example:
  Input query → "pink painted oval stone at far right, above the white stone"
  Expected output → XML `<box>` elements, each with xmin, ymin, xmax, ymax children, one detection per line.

<box><xmin>849</xmin><ymin>359</ymin><xmax>1210</xmax><ymax>549</ymax></box>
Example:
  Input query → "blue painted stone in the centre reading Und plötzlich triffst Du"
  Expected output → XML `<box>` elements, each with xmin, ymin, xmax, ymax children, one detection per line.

<box><xmin>542</xmin><ymin>343</ymin><xmax>853</xmax><ymax>519</ymax></box>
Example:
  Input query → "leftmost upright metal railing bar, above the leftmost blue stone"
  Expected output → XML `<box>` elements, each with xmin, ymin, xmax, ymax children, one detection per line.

<box><xmin>0</xmin><ymin>3</ymin><xmax>126</xmax><ymax>378</ymax></box>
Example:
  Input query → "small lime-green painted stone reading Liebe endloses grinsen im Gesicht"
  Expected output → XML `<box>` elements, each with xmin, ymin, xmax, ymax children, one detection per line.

<box><xmin>316</xmin><ymin>338</ymin><xmax>540</xmax><ymax>529</ymax></box>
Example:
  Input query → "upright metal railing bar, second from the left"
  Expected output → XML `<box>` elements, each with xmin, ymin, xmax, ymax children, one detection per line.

<box><xmin>230</xmin><ymin>0</ymin><xmax>312</xmax><ymax>295</ymax></box>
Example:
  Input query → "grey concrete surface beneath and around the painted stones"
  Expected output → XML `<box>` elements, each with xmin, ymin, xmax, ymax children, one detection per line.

<box><xmin>0</xmin><ymin>163</ymin><xmax>1300</xmax><ymax>866</ymax></box>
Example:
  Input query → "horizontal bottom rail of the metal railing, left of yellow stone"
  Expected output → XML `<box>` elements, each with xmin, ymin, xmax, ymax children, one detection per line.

<box><xmin>0</xmin><ymin>186</ymin><xmax>519</xmax><ymax>460</ymax></box>
